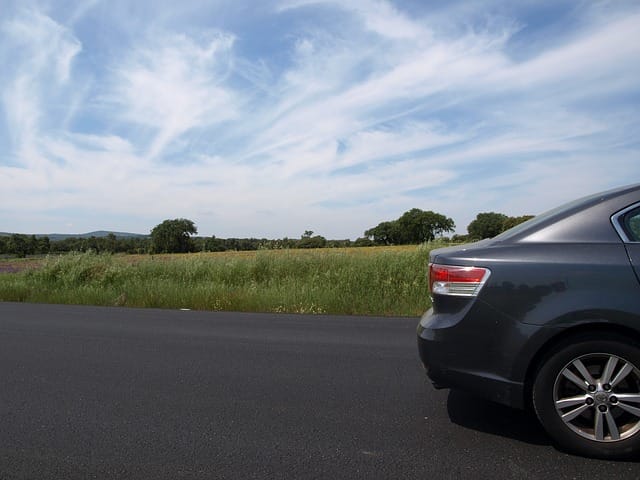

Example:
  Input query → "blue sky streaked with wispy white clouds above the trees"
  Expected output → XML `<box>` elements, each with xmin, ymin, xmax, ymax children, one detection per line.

<box><xmin>0</xmin><ymin>0</ymin><xmax>640</xmax><ymax>239</ymax></box>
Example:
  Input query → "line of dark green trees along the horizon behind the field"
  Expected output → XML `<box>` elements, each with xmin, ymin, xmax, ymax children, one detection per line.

<box><xmin>0</xmin><ymin>208</ymin><xmax>532</xmax><ymax>257</ymax></box>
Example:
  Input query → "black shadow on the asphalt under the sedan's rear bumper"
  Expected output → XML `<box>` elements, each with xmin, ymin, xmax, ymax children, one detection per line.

<box><xmin>447</xmin><ymin>390</ymin><xmax>551</xmax><ymax>445</ymax></box>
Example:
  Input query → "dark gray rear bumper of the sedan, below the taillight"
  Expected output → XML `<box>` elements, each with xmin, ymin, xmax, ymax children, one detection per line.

<box><xmin>417</xmin><ymin>310</ymin><xmax>525</xmax><ymax>408</ymax></box>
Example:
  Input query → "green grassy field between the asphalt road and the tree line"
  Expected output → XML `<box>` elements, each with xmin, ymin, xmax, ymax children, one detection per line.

<box><xmin>0</xmin><ymin>245</ymin><xmax>441</xmax><ymax>316</ymax></box>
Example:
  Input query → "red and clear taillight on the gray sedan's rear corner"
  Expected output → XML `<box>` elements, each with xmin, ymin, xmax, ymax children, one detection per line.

<box><xmin>429</xmin><ymin>263</ymin><xmax>491</xmax><ymax>296</ymax></box>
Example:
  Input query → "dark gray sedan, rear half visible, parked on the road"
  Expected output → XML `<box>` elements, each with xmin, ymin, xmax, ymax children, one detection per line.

<box><xmin>418</xmin><ymin>184</ymin><xmax>640</xmax><ymax>458</ymax></box>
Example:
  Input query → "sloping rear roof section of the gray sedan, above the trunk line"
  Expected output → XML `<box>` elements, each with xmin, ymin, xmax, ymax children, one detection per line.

<box><xmin>493</xmin><ymin>183</ymin><xmax>640</xmax><ymax>243</ymax></box>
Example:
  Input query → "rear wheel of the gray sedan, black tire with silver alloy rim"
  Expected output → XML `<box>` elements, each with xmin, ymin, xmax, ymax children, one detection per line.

<box><xmin>533</xmin><ymin>334</ymin><xmax>640</xmax><ymax>459</ymax></box>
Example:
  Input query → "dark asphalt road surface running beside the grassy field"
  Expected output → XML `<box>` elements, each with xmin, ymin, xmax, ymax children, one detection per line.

<box><xmin>0</xmin><ymin>303</ymin><xmax>640</xmax><ymax>480</ymax></box>
